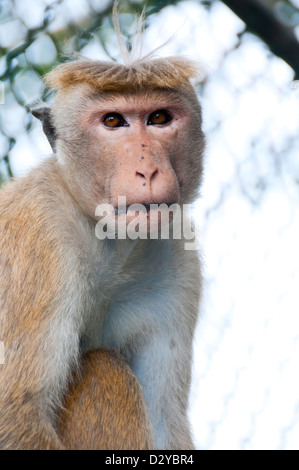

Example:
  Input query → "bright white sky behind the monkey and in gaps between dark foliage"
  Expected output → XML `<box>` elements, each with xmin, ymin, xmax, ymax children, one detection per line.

<box><xmin>0</xmin><ymin>0</ymin><xmax>299</xmax><ymax>449</ymax></box>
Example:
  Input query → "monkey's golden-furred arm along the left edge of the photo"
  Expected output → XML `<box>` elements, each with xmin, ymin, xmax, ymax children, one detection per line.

<box><xmin>0</xmin><ymin>170</ymin><xmax>81</xmax><ymax>449</ymax></box>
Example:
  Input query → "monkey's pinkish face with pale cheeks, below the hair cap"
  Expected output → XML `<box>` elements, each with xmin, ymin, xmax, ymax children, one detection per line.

<box><xmin>54</xmin><ymin>86</ymin><xmax>204</xmax><ymax>229</ymax></box>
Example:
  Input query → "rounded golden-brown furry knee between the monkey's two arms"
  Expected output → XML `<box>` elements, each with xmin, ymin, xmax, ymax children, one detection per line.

<box><xmin>59</xmin><ymin>349</ymin><xmax>153</xmax><ymax>450</ymax></box>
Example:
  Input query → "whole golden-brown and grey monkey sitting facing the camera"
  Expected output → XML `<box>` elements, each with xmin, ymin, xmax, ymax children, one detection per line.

<box><xmin>0</xmin><ymin>39</ymin><xmax>205</xmax><ymax>450</ymax></box>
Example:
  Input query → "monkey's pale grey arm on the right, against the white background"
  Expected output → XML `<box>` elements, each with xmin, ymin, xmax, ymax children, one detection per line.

<box><xmin>142</xmin><ymin>246</ymin><xmax>201</xmax><ymax>450</ymax></box>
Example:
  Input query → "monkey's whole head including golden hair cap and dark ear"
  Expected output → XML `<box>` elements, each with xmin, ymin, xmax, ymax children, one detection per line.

<box><xmin>34</xmin><ymin>57</ymin><xmax>204</xmax><ymax>228</ymax></box>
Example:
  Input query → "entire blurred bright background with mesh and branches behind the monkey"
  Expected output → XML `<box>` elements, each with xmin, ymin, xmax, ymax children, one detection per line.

<box><xmin>0</xmin><ymin>0</ymin><xmax>299</xmax><ymax>450</ymax></box>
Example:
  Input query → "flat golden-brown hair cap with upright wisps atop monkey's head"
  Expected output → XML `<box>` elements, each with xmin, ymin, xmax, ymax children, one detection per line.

<box><xmin>45</xmin><ymin>0</ymin><xmax>201</xmax><ymax>92</ymax></box>
